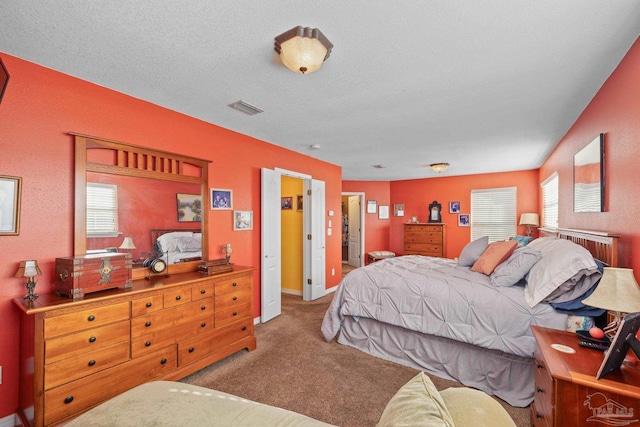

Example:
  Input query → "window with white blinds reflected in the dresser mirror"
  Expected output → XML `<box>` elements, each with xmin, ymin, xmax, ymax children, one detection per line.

<box><xmin>87</xmin><ymin>182</ymin><xmax>118</xmax><ymax>237</ymax></box>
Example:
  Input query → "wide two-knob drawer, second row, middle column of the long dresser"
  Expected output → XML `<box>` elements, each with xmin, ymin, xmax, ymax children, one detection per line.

<box><xmin>131</xmin><ymin>298</ymin><xmax>214</xmax><ymax>337</ymax></box>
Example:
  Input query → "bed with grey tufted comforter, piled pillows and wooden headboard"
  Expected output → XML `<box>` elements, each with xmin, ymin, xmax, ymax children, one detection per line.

<box><xmin>322</xmin><ymin>229</ymin><xmax>619</xmax><ymax>407</ymax></box>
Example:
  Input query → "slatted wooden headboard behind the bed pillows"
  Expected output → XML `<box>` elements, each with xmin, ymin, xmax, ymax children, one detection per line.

<box><xmin>540</xmin><ymin>228</ymin><xmax>620</xmax><ymax>267</ymax></box>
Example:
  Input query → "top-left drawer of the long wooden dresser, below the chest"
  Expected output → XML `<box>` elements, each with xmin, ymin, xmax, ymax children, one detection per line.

<box><xmin>44</xmin><ymin>301</ymin><xmax>130</xmax><ymax>339</ymax></box>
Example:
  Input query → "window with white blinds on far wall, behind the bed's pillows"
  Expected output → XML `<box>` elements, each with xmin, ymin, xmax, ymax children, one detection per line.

<box><xmin>471</xmin><ymin>187</ymin><xmax>518</xmax><ymax>242</ymax></box>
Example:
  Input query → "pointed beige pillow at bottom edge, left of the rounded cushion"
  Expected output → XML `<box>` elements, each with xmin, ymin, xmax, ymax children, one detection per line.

<box><xmin>377</xmin><ymin>372</ymin><xmax>454</xmax><ymax>427</ymax></box>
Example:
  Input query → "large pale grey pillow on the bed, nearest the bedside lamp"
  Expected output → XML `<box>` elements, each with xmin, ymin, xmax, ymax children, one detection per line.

<box><xmin>524</xmin><ymin>238</ymin><xmax>601</xmax><ymax>307</ymax></box>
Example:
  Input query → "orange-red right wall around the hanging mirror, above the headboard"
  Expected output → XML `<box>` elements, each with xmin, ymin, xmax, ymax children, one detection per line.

<box><xmin>539</xmin><ymin>39</ymin><xmax>640</xmax><ymax>281</ymax></box>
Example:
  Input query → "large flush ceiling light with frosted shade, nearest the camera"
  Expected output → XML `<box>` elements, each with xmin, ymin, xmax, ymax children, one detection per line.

<box><xmin>274</xmin><ymin>26</ymin><xmax>333</xmax><ymax>74</ymax></box>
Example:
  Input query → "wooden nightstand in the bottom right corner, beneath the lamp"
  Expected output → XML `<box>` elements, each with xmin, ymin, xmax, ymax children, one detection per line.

<box><xmin>531</xmin><ymin>326</ymin><xmax>640</xmax><ymax>427</ymax></box>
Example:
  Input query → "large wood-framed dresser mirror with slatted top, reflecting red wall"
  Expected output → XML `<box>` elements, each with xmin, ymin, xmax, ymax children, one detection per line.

<box><xmin>72</xmin><ymin>133</ymin><xmax>209</xmax><ymax>279</ymax></box>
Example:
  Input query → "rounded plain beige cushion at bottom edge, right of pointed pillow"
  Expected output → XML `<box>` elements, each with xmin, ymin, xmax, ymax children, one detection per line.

<box><xmin>440</xmin><ymin>387</ymin><xmax>516</xmax><ymax>427</ymax></box>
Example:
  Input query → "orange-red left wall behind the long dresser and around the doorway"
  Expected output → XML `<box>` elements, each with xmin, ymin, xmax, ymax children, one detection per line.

<box><xmin>0</xmin><ymin>52</ymin><xmax>341</xmax><ymax>418</ymax></box>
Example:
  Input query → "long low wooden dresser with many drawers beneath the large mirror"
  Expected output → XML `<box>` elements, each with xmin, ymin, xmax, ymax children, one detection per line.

<box><xmin>14</xmin><ymin>267</ymin><xmax>256</xmax><ymax>427</ymax></box>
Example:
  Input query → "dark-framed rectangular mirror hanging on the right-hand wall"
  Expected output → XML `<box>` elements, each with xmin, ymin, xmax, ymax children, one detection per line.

<box><xmin>573</xmin><ymin>133</ymin><xmax>605</xmax><ymax>212</ymax></box>
